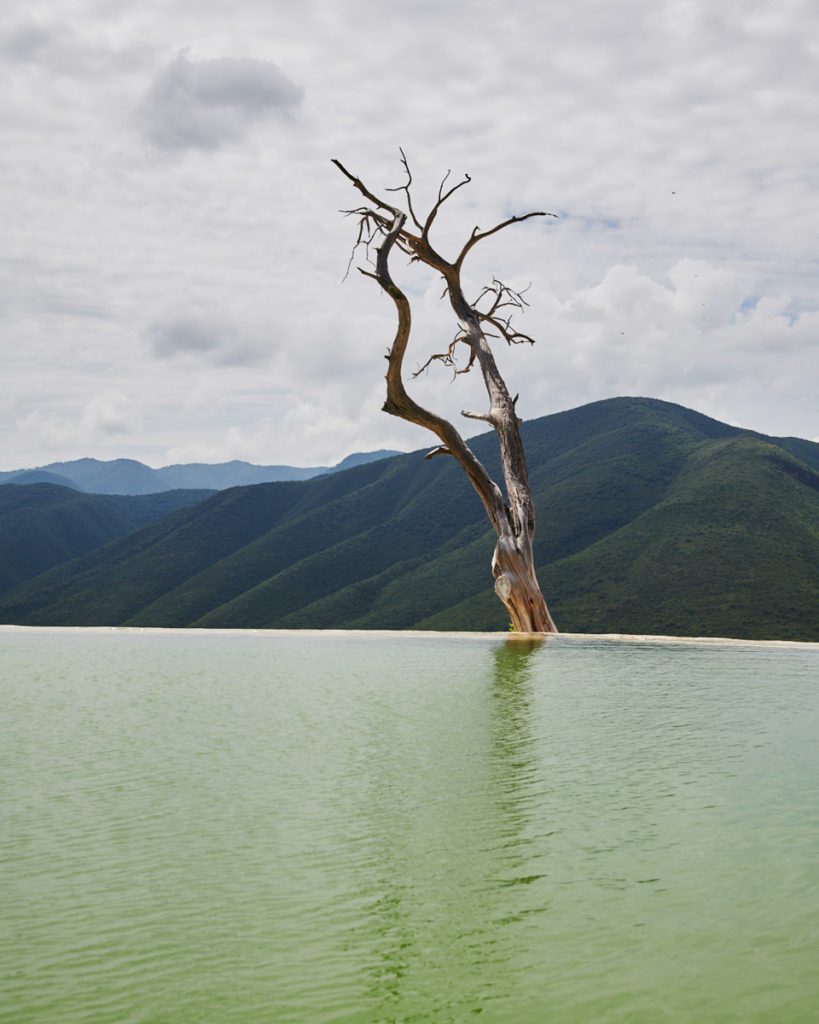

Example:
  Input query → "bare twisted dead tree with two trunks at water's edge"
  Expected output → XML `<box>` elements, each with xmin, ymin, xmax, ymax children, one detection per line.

<box><xmin>333</xmin><ymin>151</ymin><xmax>557</xmax><ymax>633</ymax></box>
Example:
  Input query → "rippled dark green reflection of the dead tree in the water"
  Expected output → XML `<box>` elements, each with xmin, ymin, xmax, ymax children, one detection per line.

<box><xmin>367</xmin><ymin>639</ymin><xmax>548</xmax><ymax>1021</ymax></box>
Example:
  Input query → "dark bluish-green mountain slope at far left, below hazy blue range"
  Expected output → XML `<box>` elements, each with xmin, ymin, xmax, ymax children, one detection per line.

<box><xmin>0</xmin><ymin>485</ymin><xmax>212</xmax><ymax>594</ymax></box>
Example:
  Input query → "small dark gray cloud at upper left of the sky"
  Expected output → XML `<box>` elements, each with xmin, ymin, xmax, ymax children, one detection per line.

<box><xmin>138</xmin><ymin>52</ymin><xmax>303</xmax><ymax>150</ymax></box>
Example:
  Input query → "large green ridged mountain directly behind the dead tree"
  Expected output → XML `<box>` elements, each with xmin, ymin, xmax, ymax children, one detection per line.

<box><xmin>0</xmin><ymin>398</ymin><xmax>819</xmax><ymax>640</ymax></box>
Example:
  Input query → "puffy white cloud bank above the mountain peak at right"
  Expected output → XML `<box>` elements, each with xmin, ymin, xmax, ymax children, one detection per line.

<box><xmin>510</xmin><ymin>259</ymin><xmax>819</xmax><ymax>434</ymax></box>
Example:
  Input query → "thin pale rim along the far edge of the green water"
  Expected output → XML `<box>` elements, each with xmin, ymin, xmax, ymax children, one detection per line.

<box><xmin>0</xmin><ymin>624</ymin><xmax>819</xmax><ymax>650</ymax></box>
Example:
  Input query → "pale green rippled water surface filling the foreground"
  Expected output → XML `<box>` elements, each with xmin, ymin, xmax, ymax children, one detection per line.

<box><xmin>0</xmin><ymin>630</ymin><xmax>819</xmax><ymax>1024</ymax></box>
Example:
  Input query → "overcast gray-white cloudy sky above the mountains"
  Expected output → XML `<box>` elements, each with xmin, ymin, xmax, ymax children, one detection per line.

<box><xmin>0</xmin><ymin>0</ymin><xmax>819</xmax><ymax>469</ymax></box>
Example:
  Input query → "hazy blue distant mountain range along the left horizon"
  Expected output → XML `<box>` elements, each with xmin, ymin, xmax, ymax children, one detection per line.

<box><xmin>0</xmin><ymin>449</ymin><xmax>400</xmax><ymax>495</ymax></box>
